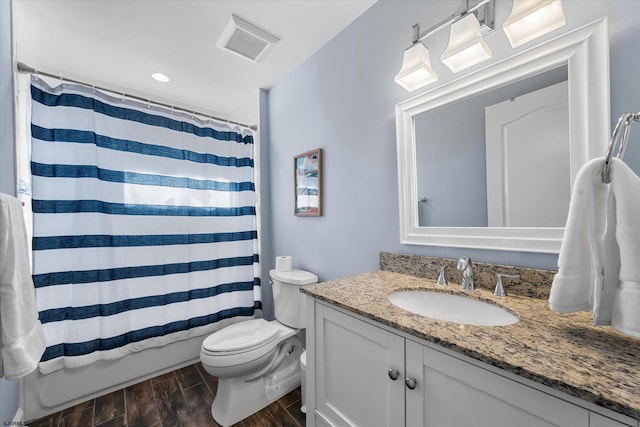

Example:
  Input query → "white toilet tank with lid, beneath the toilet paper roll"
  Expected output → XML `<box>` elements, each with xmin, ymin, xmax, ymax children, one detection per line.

<box><xmin>269</xmin><ymin>270</ymin><xmax>318</xmax><ymax>329</ymax></box>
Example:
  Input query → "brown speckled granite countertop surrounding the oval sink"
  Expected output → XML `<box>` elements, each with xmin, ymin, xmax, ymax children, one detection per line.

<box><xmin>302</xmin><ymin>270</ymin><xmax>640</xmax><ymax>420</ymax></box>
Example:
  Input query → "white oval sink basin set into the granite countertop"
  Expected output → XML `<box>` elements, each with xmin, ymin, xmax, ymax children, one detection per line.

<box><xmin>387</xmin><ymin>291</ymin><xmax>519</xmax><ymax>326</ymax></box>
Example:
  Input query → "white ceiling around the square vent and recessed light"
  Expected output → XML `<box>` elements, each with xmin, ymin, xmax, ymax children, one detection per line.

<box><xmin>13</xmin><ymin>0</ymin><xmax>375</xmax><ymax>124</ymax></box>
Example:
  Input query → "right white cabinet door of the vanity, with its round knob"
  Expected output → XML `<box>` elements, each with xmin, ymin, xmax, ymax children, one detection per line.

<box><xmin>406</xmin><ymin>340</ymin><xmax>589</xmax><ymax>427</ymax></box>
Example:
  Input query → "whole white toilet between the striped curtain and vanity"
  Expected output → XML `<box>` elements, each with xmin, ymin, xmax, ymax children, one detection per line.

<box><xmin>200</xmin><ymin>270</ymin><xmax>318</xmax><ymax>427</ymax></box>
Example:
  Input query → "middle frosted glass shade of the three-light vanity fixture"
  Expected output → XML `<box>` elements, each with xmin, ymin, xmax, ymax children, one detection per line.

<box><xmin>440</xmin><ymin>13</ymin><xmax>491</xmax><ymax>73</ymax></box>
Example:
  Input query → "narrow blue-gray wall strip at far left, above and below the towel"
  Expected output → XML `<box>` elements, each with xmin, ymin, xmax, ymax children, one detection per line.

<box><xmin>0</xmin><ymin>0</ymin><xmax>19</xmax><ymax>424</ymax></box>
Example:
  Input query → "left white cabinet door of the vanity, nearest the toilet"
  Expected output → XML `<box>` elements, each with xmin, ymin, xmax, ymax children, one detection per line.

<box><xmin>315</xmin><ymin>304</ymin><xmax>404</xmax><ymax>427</ymax></box>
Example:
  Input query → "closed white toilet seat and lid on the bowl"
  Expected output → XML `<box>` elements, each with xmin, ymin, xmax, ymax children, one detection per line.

<box><xmin>200</xmin><ymin>319</ymin><xmax>297</xmax><ymax>368</ymax></box>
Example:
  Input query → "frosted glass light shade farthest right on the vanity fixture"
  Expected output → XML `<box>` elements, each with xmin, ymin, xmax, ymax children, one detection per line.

<box><xmin>502</xmin><ymin>0</ymin><xmax>567</xmax><ymax>47</ymax></box>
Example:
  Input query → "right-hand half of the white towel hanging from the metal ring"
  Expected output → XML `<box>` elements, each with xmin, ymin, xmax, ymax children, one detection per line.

<box><xmin>611</xmin><ymin>158</ymin><xmax>640</xmax><ymax>338</ymax></box>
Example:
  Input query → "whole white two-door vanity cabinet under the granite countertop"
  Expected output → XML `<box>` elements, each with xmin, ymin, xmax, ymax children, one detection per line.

<box><xmin>307</xmin><ymin>301</ymin><xmax>638</xmax><ymax>427</ymax></box>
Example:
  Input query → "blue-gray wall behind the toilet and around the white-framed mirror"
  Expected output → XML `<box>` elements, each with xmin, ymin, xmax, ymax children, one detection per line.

<box><xmin>263</xmin><ymin>0</ymin><xmax>640</xmax><ymax>280</ymax></box>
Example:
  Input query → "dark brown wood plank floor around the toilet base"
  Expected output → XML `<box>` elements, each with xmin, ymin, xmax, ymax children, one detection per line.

<box><xmin>27</xmin><ymin>363</ymin><xmax>305</xmax><ymax>427</ymax></box>
